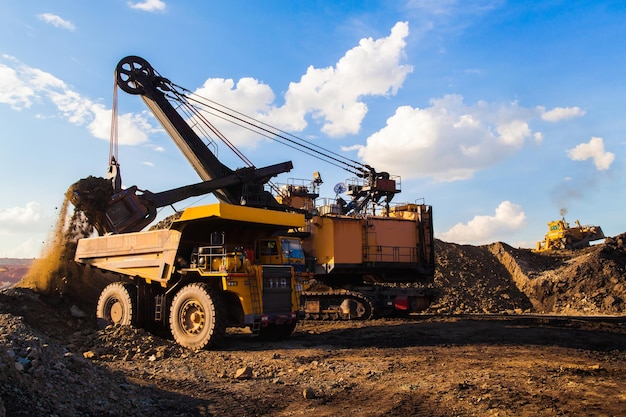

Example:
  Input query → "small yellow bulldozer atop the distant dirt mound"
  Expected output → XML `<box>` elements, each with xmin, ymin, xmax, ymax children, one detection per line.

<box><xmin>535</xmin><ymin>218</ymin><xmax>604</xmax><ymax>252</ymax></box>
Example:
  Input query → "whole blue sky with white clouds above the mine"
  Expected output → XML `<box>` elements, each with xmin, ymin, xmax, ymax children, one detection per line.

<box><xmin>0</xmin><ymin>0</ymin><xmax>626</xmax><ymax>257</ymax></box>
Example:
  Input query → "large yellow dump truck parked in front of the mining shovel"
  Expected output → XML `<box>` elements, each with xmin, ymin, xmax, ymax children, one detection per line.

<box><xmin>75</xmin><ymin>203</ymin><xmax>305</xmax><ymax>349</ymax></box>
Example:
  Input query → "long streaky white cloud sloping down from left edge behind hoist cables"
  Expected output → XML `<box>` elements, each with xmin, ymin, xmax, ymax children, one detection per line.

<box><xmin>0</xmin><ymin>56</ymin><xmax>158</xmax><ymax>145</ymax></box>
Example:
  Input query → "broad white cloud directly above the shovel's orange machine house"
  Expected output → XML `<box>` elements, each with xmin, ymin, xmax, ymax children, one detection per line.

<box><xmin>357</xmin><ymin>95</ymin><xmax>541</xmax><ymax>181</ymax></box>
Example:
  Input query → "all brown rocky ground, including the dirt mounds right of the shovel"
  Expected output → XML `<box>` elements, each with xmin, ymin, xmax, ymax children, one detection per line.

<box><xmin>0</xmin><ymin>234</ymin><xmax>626</xmax><ymax>417</ymax></box>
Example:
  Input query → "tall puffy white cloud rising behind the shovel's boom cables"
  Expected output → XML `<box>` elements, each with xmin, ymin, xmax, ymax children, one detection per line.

<box><xmin>189</xmin><ymin>22</ymin><xmax>412</xmax><ymax>146</ymax></box>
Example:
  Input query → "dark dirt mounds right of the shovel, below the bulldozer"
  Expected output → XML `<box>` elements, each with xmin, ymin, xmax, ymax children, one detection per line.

<box><xmin>429</xmin><ymin>234</ymin><xmax>626</xmax><ymax>315</ymax></box>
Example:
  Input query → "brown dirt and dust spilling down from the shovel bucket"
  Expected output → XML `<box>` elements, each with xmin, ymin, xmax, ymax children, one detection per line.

<box><xmin>17</xmin><ymin>177</ymin><xmax>111</xmax><ymax>303</ymax></box>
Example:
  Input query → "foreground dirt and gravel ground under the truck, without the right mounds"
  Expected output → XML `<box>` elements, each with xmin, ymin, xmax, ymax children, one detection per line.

<box><xmin>0</xmin><ymin>289</ymin><xmax>626</xmax><ymax>416</ymax></box>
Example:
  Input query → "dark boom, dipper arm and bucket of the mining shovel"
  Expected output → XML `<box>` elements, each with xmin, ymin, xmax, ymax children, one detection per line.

<box><xmin>72</xmin><ymin>56</ymin><xmax>293</xmax><ymax>234</ymax></box>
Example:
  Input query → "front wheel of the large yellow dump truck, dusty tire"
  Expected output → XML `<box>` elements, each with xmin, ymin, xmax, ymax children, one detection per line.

<box><xmin>170</xmin><ymin>283</ymin><xmax>227</xmax><ymax>350</ymax></box>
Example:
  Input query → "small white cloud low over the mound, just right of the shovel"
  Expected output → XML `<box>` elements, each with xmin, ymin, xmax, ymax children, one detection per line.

<box><xmin>437</xmin><ymin>201</ymin><xmax>526</xmax><ymax>245</ymax></box>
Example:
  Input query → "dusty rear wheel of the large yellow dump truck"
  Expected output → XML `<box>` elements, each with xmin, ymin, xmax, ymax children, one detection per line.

<box><xmin>96</xmin><ymin>282</ymin><xmax>137</xmax><ymax>329</ymax></box>
